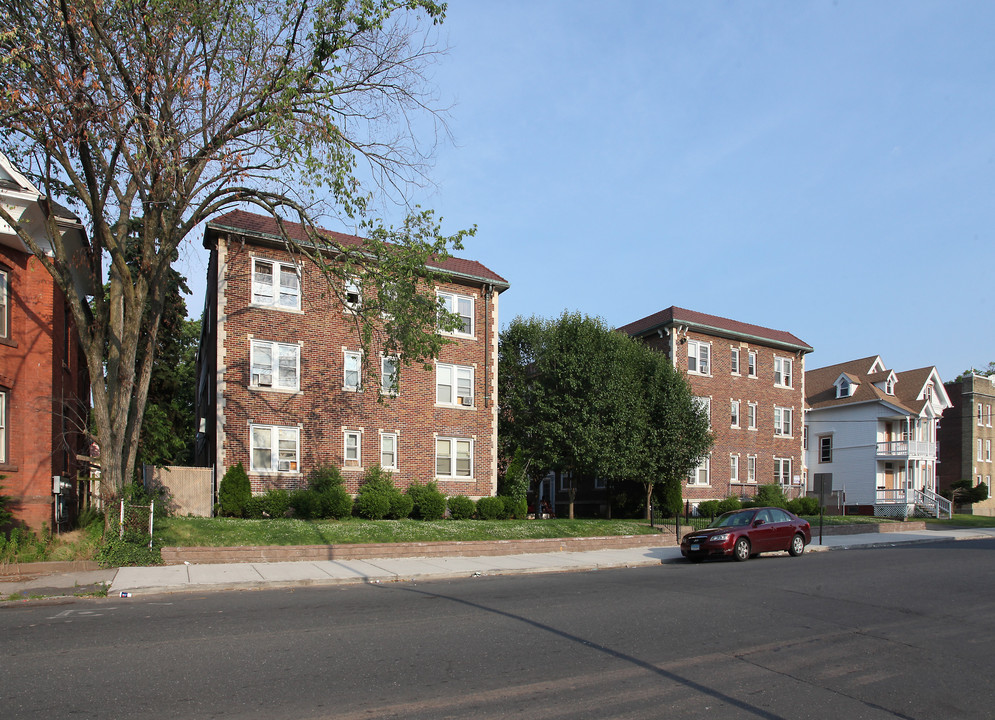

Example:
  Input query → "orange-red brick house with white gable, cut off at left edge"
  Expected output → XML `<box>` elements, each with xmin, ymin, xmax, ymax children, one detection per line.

<box><xmin>0</xmin><ymin>154</ymin><xmax>90</xmax><ymax>530</ymax></box>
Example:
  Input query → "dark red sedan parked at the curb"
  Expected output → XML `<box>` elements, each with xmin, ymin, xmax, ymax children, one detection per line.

<box><xmin>681</xmin><ymin>508</ymin><xmax>812</xmax><ymax>562</ymax></box>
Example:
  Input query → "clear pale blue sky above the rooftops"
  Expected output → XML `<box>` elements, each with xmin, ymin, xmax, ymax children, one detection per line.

<box><xmin>190</xmin><ymin>0</ymin><xmax>995</xmax><ymax>379</ymax></box>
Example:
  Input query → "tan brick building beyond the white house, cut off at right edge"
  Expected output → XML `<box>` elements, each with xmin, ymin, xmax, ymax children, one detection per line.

<box><xmin>937</xmin><ymin>375</ymin><xmax>995</xmax><ymax>511</ymax></box>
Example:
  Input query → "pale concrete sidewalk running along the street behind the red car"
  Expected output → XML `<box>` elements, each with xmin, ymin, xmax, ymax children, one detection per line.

<box><xmin>0</xmin><ymin>528</ymin><xmax>995</xmax><ymax>599</ymax></box>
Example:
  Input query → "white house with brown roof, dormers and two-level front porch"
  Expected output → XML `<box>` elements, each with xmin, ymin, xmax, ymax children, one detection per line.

<box><xmin>803</xmin><ymin>355</ymin><xmax>951</xmax><ymax>517</ymax></box>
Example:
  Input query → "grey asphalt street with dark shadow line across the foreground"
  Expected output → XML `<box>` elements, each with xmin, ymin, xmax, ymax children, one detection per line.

<box><xmin>0</xmin><ymin>539</ymin><xmax>995</xmax><ymax>720</ymax></box>
